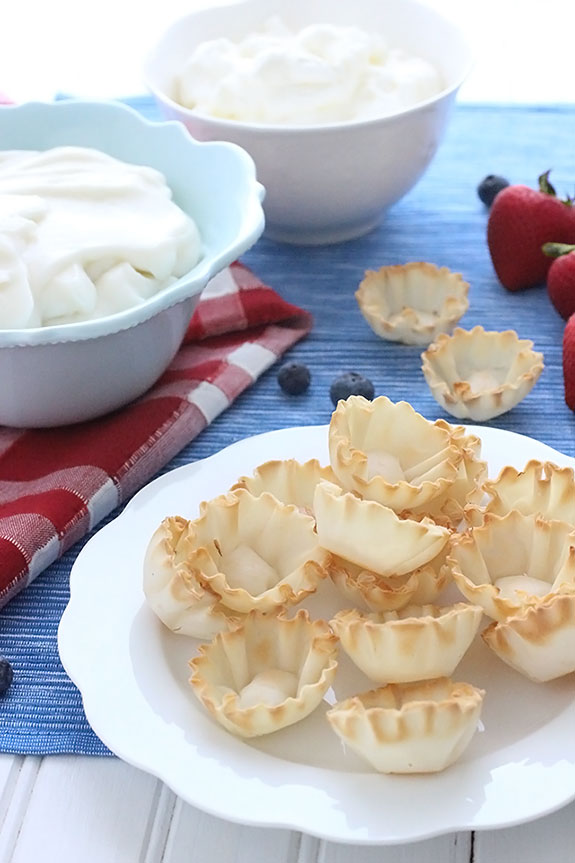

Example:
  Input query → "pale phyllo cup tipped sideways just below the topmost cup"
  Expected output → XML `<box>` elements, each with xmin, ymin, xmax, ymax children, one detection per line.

<box><xmin>313</xmin><ymin>482</ymin><xmax>450</xmax><ymax>576</ymax></box>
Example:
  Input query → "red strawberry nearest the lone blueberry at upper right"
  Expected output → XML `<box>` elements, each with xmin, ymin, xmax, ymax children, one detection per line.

<box><xmin>487</xmin><ymin>171</ymin><xmax>575</xmax><ymax>291</ymax></box>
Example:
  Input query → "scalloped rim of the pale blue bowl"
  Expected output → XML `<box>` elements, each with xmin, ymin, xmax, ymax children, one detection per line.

<box><xmin>0</xmin><ymin>99</ymin><xmax>265</xmax><ymax>348</ymax></box>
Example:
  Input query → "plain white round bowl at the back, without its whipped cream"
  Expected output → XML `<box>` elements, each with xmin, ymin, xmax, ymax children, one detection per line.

<box><xmin>145</xmin><ymin>0</ymin><xmax>471</xmax><ymax>244</ymax></box>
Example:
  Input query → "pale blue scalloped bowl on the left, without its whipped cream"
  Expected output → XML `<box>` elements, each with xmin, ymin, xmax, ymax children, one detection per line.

<box><xmin>0</xmin><ymin>101</ymin><xmax>264</xmax><ymax>427</ymax></box>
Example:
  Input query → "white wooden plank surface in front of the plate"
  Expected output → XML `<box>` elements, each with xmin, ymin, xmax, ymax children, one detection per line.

<box><xmin>0</xmin><ymin>755</ymin><xmax>575</xmax><ymax>863</ymax></box>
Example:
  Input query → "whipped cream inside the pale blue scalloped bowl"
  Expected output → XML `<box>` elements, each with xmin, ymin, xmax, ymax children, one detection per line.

<box><xmin>0</xmin><ymin>146</ymin><xmax>201</xmax><ymax>329</ymax></box>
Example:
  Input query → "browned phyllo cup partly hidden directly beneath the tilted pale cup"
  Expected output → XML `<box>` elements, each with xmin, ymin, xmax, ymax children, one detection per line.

<box><xmin>327</xmin><ymin>549</ymin><xmax>448</xmax><ymax>611</ymax></box>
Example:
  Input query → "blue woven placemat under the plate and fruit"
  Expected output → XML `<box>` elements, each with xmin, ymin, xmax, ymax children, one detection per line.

<box><xmin>0</xmin><ymin>97</ymin><xmax>575</xmax><ymax>755</ymax></box>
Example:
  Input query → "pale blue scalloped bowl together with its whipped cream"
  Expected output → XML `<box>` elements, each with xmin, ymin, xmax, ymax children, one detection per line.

<box><xmin>0</xmin><ymin>100</ymin><xmax>264</xmax><ymax>427</ymax></box>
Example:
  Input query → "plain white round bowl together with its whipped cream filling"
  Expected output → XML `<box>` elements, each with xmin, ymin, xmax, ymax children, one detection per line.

<box><xmin>144</xmin><ymin>0</ymin><xmax>471</xmax><ymax>245</ymax></box>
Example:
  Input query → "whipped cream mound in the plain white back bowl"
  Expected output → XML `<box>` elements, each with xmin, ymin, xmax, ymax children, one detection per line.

<box><xmin>176</xmin><ymin>16</ymin><xmax>444</xmax><ymax>126</ymax></box>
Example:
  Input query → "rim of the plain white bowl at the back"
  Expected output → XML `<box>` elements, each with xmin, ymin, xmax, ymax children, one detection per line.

<box><xmin>143</xmin><ymin>0</ymin><xmax>475</xmax><ymax>137</ymax></box>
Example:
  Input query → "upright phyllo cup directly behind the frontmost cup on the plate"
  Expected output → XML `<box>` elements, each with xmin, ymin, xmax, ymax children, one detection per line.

<box><xmin>330</xmin><ymin>602</ymin><xmax>483</xmax><ymax>683</ymax></box>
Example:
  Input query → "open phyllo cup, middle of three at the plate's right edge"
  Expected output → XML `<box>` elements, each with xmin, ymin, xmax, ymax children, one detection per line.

<box><xmin>445</xmin><ymin>510</ymin><xmax>575</xmax><ymax>621</ymax></box>
